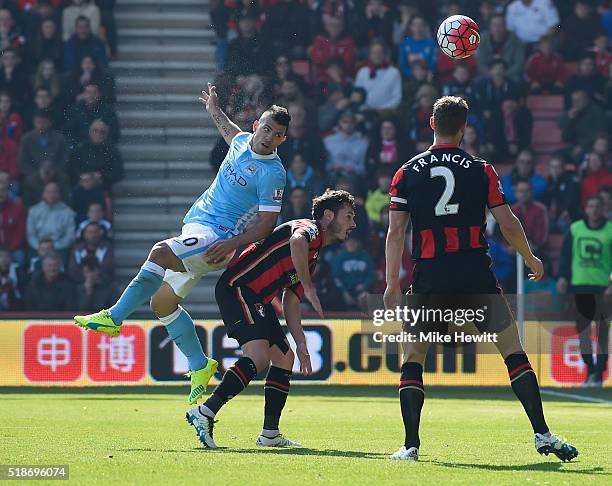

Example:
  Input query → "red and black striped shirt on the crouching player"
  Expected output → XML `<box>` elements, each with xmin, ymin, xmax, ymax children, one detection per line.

<box><xmin>223</xmin><ymin>219</ymin><xmax>324</xmax><ymax>304</ymax></box>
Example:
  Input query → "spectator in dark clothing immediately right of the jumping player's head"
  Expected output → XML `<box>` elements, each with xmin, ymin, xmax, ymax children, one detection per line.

<box><xmin>277</xmin><ymin>105</ymin><xmax>326</xmax><ymax>172</ymax></box>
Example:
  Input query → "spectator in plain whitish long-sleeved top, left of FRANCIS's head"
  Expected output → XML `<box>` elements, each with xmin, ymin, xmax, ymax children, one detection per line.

<box><xmin>355</xmin><ymin>38</ymin><xmax>402</xmax><ymax>110</ymax></box>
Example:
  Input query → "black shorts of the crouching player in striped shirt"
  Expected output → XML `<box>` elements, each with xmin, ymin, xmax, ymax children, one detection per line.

<box><xmin>215</xmin><ymin>279</ymin><xmax>289</xmax><ymax>353</ymax></box>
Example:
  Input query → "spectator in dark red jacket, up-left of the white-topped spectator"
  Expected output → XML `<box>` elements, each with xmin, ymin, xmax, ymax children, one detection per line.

<box><xmin>308</xmin><ymin>13</ymin><xmax>357</xmax><ymax>82</ymax></box>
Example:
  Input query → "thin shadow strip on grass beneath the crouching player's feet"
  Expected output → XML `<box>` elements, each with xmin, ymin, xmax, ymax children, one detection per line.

<box><xmin>119</xmin><ymin>447</ymin><xmax>389</xmax><ymax>459</ymax></box>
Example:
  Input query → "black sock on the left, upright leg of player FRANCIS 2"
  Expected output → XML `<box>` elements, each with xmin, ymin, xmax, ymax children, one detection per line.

<box><xmin>399</xmin><ymin>362</ymin><xmax>425</xmax><ymax>449</ymax></box>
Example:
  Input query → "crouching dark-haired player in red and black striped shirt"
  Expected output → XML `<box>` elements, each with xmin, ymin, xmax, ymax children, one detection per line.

<box><xmin>186</xmin><ymin>189</ymin><xmax>355</xmax><ymax>449</ymax></box>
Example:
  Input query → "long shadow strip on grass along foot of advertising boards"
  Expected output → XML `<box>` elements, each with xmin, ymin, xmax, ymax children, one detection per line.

<box><xmin>0</xmin><ymin>381</ymin><xmax>612</xmax><ymax>403</ymax></box>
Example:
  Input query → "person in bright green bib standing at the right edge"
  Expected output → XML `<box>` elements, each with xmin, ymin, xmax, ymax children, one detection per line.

<box><xmin>557</xmin><ymin>196</ymin><xmax>612</xmax><ymax>386</ymax></box>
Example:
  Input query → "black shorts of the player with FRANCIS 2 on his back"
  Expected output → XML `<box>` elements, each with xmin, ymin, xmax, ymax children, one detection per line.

<box><xmin>408</xmin><ymin>252</ymin><xmax>515</xmax><ymax>332</ymax></box>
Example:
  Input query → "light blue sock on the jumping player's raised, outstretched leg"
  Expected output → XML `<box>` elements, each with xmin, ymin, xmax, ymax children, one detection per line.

<box><xmin>110</xmin><ymin>260</ymin><xmax>166</xmax><ymax>325</ymax></box>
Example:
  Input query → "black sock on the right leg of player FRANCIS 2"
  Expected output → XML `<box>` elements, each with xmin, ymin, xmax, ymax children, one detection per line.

<box><xmin>505</xmin><ymin>353</ymin><xmax>548</xmax><ymax>434</ymax></box>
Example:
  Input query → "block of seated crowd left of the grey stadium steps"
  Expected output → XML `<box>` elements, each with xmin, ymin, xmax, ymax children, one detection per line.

<box><xmin>0</xmin><ymin>0</ymin><xmax>123</xmax><ymax>312</ymax></box>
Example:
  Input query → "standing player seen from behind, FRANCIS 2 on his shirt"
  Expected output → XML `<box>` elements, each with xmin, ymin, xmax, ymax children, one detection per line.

<box><xmin>384</xmin><ymin>96</ymin><xmax>578</xmax><ymax>461</ymax></box>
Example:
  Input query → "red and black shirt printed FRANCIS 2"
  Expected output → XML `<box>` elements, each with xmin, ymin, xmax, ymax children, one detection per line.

<box><xmin>389</xmin><ymin>145</ymin><xmax>506</xmax><ymax>259</ymax></box>
